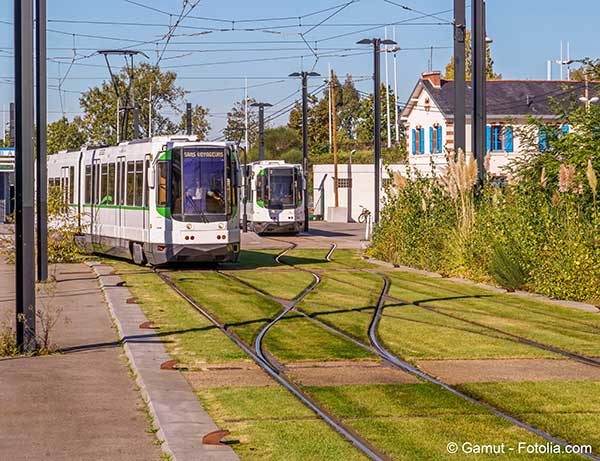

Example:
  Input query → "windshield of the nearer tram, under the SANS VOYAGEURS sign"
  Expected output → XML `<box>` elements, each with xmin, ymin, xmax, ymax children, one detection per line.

<box><xmin>171</xmin><ymin>147</ymin><xmax>229</xmax><ymax>222</ymax></box>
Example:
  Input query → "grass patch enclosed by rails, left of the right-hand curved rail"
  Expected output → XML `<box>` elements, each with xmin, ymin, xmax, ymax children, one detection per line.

<box><xmin>297</xmin><ymin>272</ymin><xmax>383</xmax><ymax>343</ymax></box>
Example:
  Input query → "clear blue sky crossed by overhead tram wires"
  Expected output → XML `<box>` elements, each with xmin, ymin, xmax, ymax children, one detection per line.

<box><xmin>0</xmin><ymin>0</ymin><xmax>600</xmax><ymax>136</ymax></box>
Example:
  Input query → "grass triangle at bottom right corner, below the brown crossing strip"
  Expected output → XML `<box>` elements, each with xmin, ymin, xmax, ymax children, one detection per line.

<box><xmin>460</xmin><ymin>381</ymin><xmax>600</xmax><ymax>453</ymax></box>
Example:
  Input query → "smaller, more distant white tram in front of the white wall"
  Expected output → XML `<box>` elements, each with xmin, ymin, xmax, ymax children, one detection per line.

<box><xmin>245</xmin><ymin>160</ymin><xmax>304</xmax><ymax>234</ymax></box>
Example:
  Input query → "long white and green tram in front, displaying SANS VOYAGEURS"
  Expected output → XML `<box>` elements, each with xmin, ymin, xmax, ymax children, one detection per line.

<box><xmin>48</xmin><ymin>136</ymin><xmax>241</xmax><ymax>265</ymax></box>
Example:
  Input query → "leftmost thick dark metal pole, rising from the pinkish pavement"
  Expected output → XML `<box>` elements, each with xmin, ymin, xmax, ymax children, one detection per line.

<box><xmin>14</xmin><ymin>0</ymin><xmax>36</xmax><ymax>352</ymax></box>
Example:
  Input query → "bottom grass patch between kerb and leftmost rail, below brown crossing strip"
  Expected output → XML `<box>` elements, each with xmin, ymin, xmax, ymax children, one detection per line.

<box><xmin>198</xmin><ymin>387</ymin><xmax>367</xmax><ymax>461</ymax></box>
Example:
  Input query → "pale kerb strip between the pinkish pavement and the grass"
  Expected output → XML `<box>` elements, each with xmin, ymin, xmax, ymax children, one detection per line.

<box><xmin>93</xmin><ymin>264</ymin><xmax>238</xmax><ymax>461</ymax></box>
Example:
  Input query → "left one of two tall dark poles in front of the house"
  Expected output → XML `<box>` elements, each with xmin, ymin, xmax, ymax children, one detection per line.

<box><xmin>454</xmin><ymin>0</ymin><xmax>467</xmax><ymax>152</ymax></box>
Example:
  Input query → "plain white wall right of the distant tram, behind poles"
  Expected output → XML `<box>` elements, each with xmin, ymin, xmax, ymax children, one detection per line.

<box><xmin>313</xmin><ymin>164</ymin><xmax>406</xmax><ymax>222</ymax></box>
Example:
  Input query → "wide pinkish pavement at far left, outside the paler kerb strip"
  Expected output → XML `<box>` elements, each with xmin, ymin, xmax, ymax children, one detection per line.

<box><xmin>0</xmin><ymin>260</ymin><xmax>162</xmax><ymax>460</ymax></box>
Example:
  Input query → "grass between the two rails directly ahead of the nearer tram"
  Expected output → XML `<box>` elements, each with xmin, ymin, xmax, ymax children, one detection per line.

<box><xmin>171</xmin><ymin>272</ymin><xmax>282</xmax><ymax>344</ymax></box>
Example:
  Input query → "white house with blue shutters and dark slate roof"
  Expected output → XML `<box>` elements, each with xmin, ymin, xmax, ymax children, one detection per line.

<box><xmin>401</xmin><ymin>72</ymin><xmax>600</xmax><ymax>175</ymax></box>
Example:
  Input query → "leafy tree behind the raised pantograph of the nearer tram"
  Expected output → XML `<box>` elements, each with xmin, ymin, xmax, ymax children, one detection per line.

<box><xmin>79</xmin><ymin>63</ymin><xmax>190</xmax><ymax>145</ymax></box>
